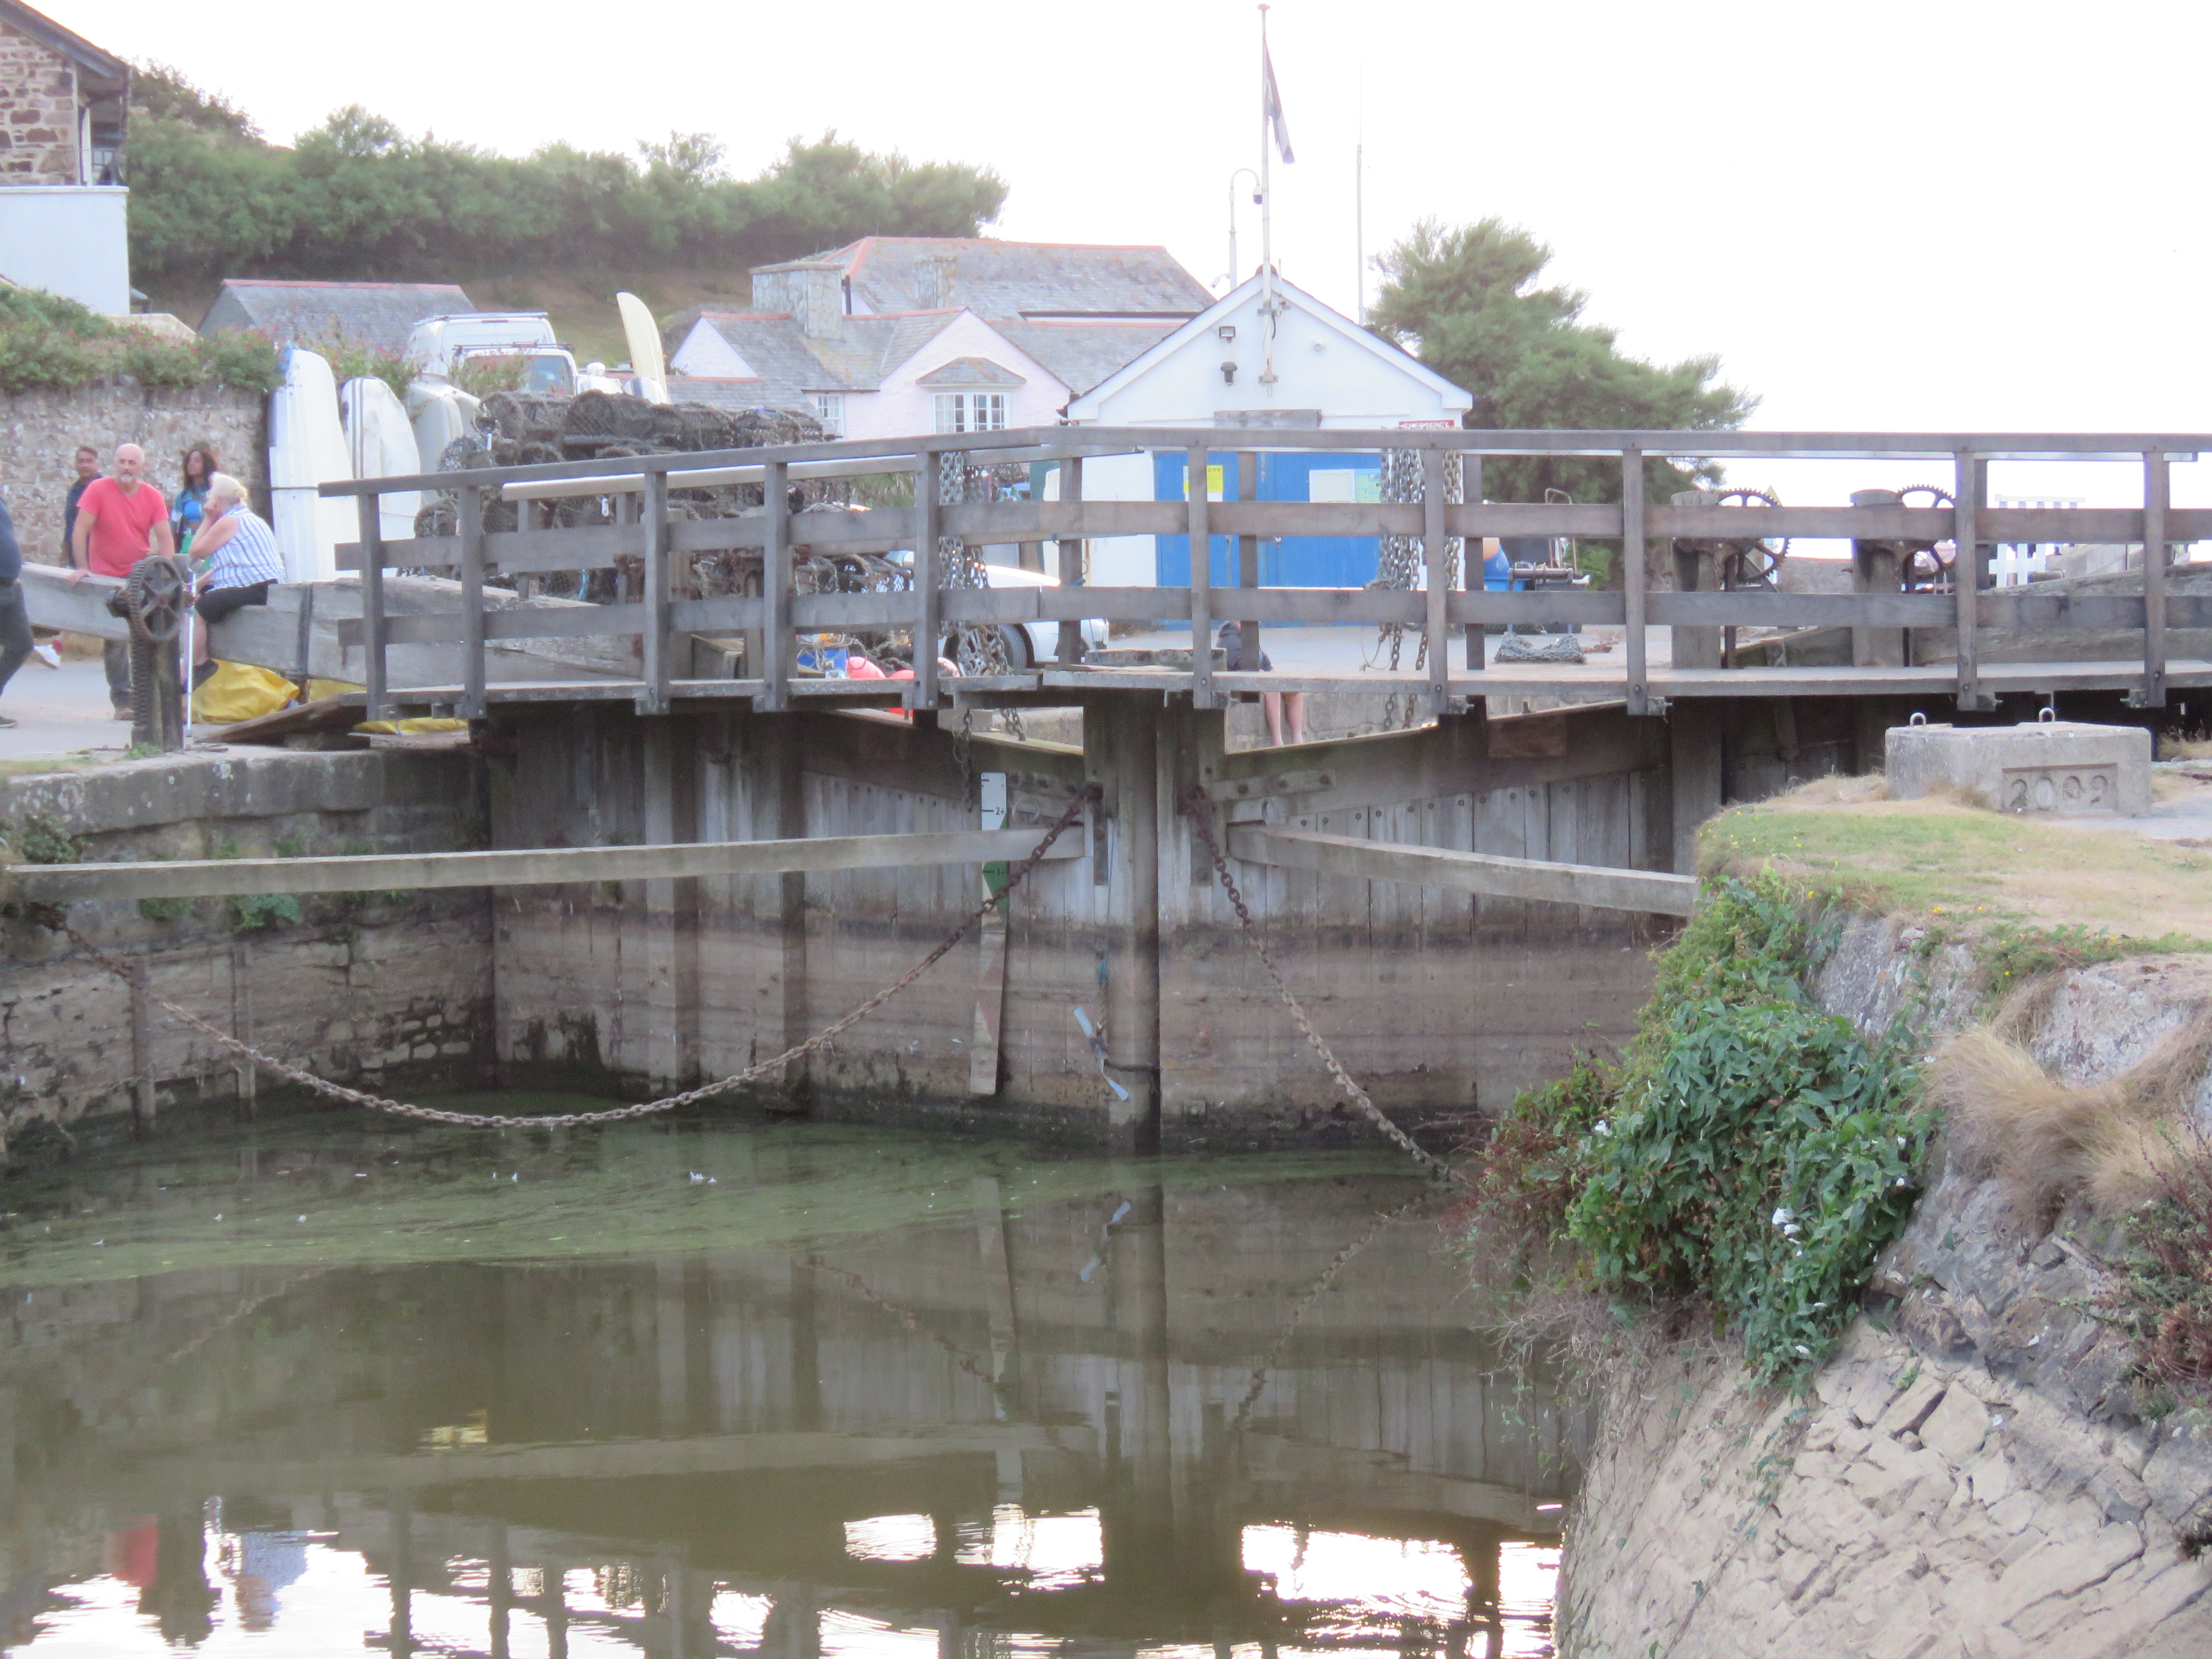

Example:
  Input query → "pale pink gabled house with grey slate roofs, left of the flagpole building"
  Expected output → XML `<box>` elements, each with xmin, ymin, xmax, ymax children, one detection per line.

<box><xmin>668</xmin><ymin>237</ymin><xmax>1212</xmax><ymax>438</ymax></box>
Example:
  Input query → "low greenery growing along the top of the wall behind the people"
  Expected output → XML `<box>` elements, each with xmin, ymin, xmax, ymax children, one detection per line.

<box><xmin>0</xmin><ymin>288</ymin><xmax>279</xmax><ymax>392</ymax></box>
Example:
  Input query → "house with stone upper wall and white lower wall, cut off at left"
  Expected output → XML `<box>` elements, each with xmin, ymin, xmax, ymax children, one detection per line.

<box><xmin>0</xmin><ymin>0</ymin><xmax>131</xmax><ymax>316</ymax></box>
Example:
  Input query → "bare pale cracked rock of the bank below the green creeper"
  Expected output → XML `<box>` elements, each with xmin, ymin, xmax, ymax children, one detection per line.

<box><xmin>1560</xmin><ymin>920</ymin><xmax>2212</xmax><ymax>1659</ymax></box>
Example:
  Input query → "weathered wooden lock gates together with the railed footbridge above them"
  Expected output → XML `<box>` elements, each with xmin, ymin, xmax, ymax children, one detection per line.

<box><xmin>15</xmin><ymin>427</ymin><xmax>2212</xmax><ymax>1143</ymax></box>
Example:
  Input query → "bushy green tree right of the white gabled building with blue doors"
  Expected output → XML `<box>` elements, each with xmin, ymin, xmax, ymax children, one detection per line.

<box><xmin>1369</xmin><ymin>219</ymin><xmax>1758</xmax><ymax>502</ymax></box>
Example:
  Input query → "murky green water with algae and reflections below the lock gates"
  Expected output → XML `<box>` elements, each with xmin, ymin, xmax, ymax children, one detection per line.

<box><xmin>0</xmin><ymin>1095</ymin><xmax>1582</xmax><ymax>1659</ymax></box>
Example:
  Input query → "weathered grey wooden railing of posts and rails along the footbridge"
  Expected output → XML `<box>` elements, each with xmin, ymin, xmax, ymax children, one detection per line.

<box><xmin>321</xmin><ymin>427</ymin><xmax>2212</xmax><ymax>717</ymax></box>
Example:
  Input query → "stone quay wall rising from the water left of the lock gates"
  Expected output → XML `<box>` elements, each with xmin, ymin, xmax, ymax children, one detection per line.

<box><xmin>0</xmin><ymin>748</ymin><xmax>491</xmax><ymax>1154</ymax></box>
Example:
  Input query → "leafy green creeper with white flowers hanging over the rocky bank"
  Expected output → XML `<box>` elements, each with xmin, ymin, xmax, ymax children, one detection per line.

<box><xmin>1473</xmin><ymin>878</ymin><xmax>1936</xmax><ymax>1380</ymax></box>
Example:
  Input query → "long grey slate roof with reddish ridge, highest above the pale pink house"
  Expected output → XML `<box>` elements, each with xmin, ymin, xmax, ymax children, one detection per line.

<box><xmin>754</xmin><ymin>237</ymin><xmax>1214</xmax><ymax>321</ymax></box>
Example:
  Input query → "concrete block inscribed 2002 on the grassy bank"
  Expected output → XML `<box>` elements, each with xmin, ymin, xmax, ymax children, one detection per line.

<box><xmin>1885</xmin><ymin>721</ymin><xmax>2150</xmax><ymax>818</ymax></box>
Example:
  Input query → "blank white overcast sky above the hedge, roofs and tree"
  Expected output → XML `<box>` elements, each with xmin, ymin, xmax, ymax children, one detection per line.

<box><xmin>44</xmin><ymin>0</ymin><xmax>2212</xmax><ymax>500</ymax></box>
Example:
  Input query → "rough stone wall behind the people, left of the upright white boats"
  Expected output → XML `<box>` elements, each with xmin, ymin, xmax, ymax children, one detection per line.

<box><xmin>0</xmin><ymin>387</ymin><xmax>268</xmax><ymax>564</ymax></box>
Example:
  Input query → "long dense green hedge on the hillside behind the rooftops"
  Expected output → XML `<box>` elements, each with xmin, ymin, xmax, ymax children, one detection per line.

<box><xmin>131</xmin><ymin>66</ymin><xmax>1007</xmax><ymax>285</ymax></box>
